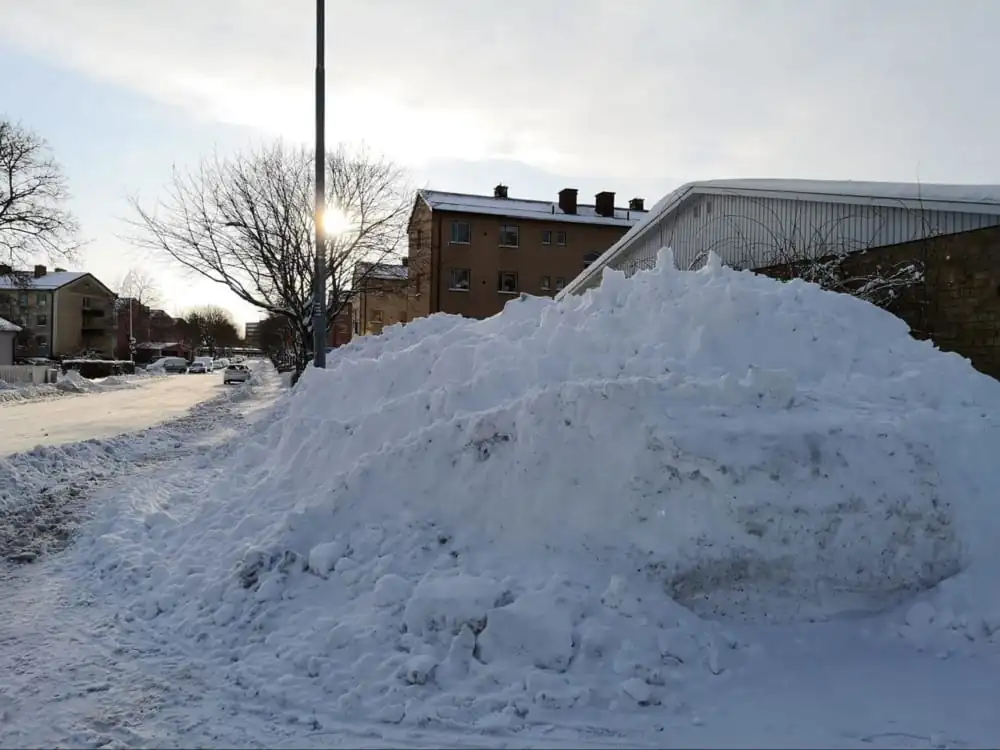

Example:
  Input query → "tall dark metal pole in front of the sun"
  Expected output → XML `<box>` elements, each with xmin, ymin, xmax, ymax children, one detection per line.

<box><xmin>313</xmin><ymin>0</ymin><xmax>326</xmax><ymax>369</ymax></box>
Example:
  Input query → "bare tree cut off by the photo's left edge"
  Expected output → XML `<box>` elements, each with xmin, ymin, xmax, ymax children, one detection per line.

<box><xmin>0</xmin><ymin>119</ymin><xmax>79</xmax><ymax>273</ymax></box>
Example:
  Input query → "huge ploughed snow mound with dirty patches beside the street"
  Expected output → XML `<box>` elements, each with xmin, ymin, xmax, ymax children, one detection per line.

<box><xmin>82</xmin><ymin>251</ymin><xmax>1000</xmax><ymax>726</ymax></box>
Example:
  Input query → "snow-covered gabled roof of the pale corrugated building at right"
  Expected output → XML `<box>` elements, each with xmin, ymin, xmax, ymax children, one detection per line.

<box><xmin>560</xmin><ymin>179</ymin><xmax>1000</xmax><ymax>296</ymax></box>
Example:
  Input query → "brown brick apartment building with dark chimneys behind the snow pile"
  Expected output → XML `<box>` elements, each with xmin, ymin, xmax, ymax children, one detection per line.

<box><xmin>404</xmin><ymin>185</ymin><xmax>646</xmax><ymax>326</ymax></box>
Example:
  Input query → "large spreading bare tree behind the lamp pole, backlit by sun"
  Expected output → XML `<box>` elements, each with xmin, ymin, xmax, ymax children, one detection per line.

<box><xmin>126</xmin><ymin>143</ymin><xmax>411</xmax><ymax>372</ymax></box>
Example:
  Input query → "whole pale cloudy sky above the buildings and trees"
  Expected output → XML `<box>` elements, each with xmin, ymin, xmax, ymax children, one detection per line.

<box><xmin>0</xmin><ymin>0</ymin><xmax>1000</xmax><ymax>328</ymax></box>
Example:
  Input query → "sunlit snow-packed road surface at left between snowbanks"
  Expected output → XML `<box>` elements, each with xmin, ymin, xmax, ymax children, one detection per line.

<box><xmin>0</xmin><ymin>373</ymin><xmax>227</xmax><ymax>456</ymax></box>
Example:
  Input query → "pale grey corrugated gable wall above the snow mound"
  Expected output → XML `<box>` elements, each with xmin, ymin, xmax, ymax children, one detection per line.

<box><xmin>600</xmin><ymin>195</ymin><xmax>1000</xmax><ymax>284</ymax></box>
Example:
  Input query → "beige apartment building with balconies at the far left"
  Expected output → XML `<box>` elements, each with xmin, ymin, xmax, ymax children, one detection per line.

<box><xmin>0</xmin><ymin>265</ymin><xmax>115</xmax><ymax>358</ymax></box>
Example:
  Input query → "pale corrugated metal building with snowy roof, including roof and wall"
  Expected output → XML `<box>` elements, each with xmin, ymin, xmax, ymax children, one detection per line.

<box><xmin>562</xmin><ymin>179</ymin><xmax>1000</xmax><ymax>294</ymax></box>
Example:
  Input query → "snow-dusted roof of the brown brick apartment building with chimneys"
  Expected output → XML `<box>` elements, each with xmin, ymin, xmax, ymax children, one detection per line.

<box><xmin>419</xmin><ymin>190</ymin><xmax>649</xmax><ymax>227</ymax></box>
